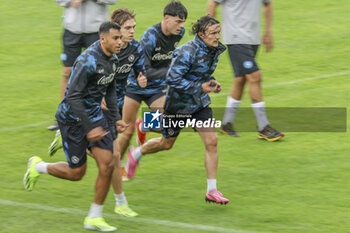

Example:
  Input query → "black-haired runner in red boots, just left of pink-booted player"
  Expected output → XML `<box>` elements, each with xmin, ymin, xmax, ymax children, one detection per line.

<box><xmin>118</xmin><ymin>1</ymin><xmax>187</xmax><ymax>164</ymax></box>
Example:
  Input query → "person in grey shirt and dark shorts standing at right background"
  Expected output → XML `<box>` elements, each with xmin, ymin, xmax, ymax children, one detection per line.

<box><xmin>208</xmin><ymin>0</ymin><xmax>284</xmax><ymax>141</ymax></box>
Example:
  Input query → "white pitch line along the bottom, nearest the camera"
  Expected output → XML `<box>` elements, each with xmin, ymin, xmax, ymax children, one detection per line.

<box><xmin>0</xmin><ymin>199</ymin><xmax>259</xmax><ymax>233</ymax></box>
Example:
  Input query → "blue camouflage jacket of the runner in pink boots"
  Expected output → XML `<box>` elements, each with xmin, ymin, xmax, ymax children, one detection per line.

<box><xmin>164</xmin><ymin>36</ymin><xmax>226</xmax><ymax>114</ymax></box>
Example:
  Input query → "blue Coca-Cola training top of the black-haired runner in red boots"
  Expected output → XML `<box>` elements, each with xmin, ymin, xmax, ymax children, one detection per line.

<box><xmin>127</xmin><ymin>23</ymin><xmax>185</xmax><ymax>94</ymax></box>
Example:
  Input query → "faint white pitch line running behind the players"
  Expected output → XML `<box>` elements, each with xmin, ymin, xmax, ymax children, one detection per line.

<box><xmin>0</xmin><ymin>71</ymin><xmax>350</xmax><ymax>132</ymax></box>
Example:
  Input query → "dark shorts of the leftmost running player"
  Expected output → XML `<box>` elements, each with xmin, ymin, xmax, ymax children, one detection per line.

<box><xmin>58</xmin><ymin>119</ymin><xmax>113</xmax><ymax>168</ymax></box>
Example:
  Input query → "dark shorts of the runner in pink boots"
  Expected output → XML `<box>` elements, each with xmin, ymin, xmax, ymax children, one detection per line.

<box><xmin>162</xmin><ymin>107</ymin><xmax>213</xmax><ymax>138</ymax></box>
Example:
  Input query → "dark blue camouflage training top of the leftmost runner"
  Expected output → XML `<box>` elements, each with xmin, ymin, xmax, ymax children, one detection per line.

<box><xmin>56</xmin><ymin>40</ymin><xmax>120</xmax><ymax>133</ymax></box>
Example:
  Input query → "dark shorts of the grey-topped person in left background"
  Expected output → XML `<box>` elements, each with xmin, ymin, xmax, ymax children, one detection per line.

<box><xmin>61</xmin><ymin>29</ymin><xmax>99</xmax><ymax>67</ymax></box>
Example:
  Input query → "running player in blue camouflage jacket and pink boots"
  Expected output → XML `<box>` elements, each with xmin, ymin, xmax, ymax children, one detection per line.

<box><xmin>128</xmin><ymin>16</ymin><xmax>229</xmax><ymax>204</ymax></box>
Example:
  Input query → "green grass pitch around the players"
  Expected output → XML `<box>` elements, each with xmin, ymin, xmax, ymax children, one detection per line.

<box><xmin>0</xmin><ymin>0</ymin><xmax>350</xmax><ymax>233</ymax></box>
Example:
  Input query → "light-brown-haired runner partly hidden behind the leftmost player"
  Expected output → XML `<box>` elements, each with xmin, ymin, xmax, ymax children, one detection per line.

<box><xmin>106</xmin><ymin>8</ymin><xmax>147</xmax><ymax>217</ymax></box>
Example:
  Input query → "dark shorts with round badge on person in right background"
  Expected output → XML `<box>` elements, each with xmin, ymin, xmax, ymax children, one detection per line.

<box><xmin>227</xmin><ymin>44</ymin><xmax>259</xmax><ymax>77</ymax></box>
